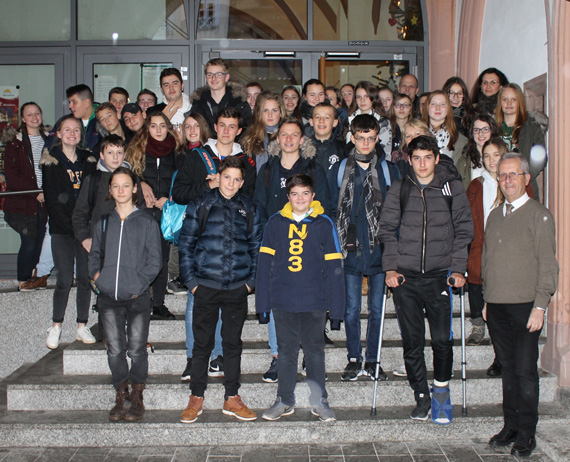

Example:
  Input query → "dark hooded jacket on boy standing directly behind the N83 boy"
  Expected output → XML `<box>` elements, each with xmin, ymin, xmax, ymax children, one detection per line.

<box><xmin>253</xmin><ymin>138</ymin><xmax>332</xmax><ymax>226</ymax></box>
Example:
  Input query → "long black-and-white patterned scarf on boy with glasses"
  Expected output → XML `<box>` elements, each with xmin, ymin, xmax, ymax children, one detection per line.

<box><xmin>336</xmin><ymin>149</ymin><xmax>382</xmax><ymax>258</ymax></box>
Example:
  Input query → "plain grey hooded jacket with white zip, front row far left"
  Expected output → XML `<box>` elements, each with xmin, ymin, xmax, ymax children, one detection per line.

<box><xmin>89</xmin><ymin>209</ymin><xmax>162</xmax><ymax>302</ymax></box>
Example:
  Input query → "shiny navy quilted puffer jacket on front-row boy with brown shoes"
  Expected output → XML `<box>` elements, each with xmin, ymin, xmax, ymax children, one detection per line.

<box><xmin>178</xmin><ymin>188</ymin><xmax>263</xmax><ymax>290</ymax></box>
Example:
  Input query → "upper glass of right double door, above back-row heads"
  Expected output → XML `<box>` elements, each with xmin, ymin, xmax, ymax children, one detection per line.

<box><xmin>326</xmin><ymin>60</ymin><xmax>409</xmax><ymax>90</ymax></box>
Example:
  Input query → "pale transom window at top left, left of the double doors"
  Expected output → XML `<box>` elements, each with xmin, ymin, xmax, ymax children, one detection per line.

<box><xmin>77</xmin><ymin>0</ymin><xmax>188</xmax><ymax>40</ymax></box>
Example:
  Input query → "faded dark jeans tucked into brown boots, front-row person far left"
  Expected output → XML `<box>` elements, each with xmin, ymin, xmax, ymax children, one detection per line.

<box><xmin>97</xmin><ymin>292</ymin><xmax>150</xmax><ymax>388</ymax></box>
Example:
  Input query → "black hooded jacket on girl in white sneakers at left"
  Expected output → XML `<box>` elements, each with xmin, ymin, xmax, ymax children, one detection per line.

<box><xmin>40</xmin><ymin>146</ymin><xmax>97</xmax><ymax>237</ymax></box>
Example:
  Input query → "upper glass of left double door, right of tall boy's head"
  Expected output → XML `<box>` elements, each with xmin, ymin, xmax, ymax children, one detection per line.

<box><xmin>220</xmin><ymin>59</ymin><xmax>303</xmax><ymax>93</ymax></box>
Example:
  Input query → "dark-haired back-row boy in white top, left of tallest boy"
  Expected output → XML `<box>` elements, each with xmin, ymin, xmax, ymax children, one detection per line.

<box><xmin>146</xmin><ymin>67</ymin><xmax>192</xmax><ymax>127</ymax></box>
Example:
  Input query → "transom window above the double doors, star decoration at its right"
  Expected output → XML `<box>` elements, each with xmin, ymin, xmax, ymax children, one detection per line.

<box><xmin>313</xmin><ymin>0</ymin><xmax>423</xmax><ymax>41</ymax></box>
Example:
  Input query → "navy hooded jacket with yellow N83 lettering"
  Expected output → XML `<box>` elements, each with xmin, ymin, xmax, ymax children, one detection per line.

<box><xmin>255</xmin><ymin>201</ymin><xmax>346</xmax><ymax>320</ymax></box>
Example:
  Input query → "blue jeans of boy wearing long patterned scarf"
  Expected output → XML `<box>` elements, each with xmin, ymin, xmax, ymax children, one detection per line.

<box><xmin>344</xmin><ymin>273</ymin><xmax>385</xmax><ymax>362</ymax></box>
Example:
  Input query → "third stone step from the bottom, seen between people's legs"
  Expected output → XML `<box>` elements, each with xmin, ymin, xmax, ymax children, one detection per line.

<box><xmin>63</xmin><ymin>339</ymin><xmax>544</xmax><ymax>375</ymax></box>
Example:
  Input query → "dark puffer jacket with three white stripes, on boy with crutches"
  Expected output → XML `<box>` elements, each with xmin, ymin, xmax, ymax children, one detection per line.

<box><xmin>380</xmin><ymin>165</ymin><xmax>473</xmax><ymax>275</ymax></box>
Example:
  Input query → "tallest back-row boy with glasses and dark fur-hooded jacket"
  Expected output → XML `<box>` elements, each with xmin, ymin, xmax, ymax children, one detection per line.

<box><xmin>190</xmin><ymin>58</ymin><xmax>251</xmax><ymax>132</ymax></box>
